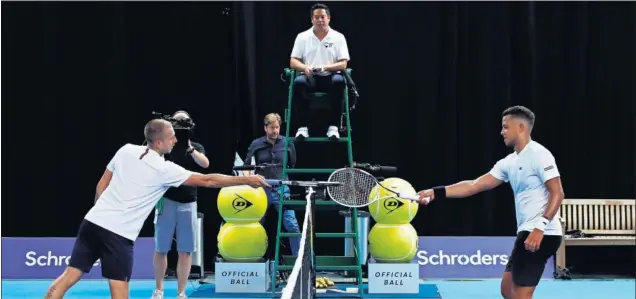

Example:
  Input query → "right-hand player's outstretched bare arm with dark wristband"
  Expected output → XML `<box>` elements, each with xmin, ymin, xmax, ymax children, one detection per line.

<box><xmin>418</xmin><ymin>173</ymin><xmax>503</xmax><ymax>204</ymax></box>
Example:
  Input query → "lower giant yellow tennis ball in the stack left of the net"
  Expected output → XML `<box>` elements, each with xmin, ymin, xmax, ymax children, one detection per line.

<box><xmin>217</xmin><ymin>222</ymin><xmax>267</xmax><ymax>263</ymax></box>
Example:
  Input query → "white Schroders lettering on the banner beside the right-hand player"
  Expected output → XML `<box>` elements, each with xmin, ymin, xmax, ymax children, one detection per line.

<box><xmin>417</xmin><ymin>249</ymin><xmax>508</xmax><ymax>266</ymax></box>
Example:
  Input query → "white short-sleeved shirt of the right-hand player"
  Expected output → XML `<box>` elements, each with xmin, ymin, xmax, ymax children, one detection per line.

<box><xmin>490</xmin><ymin>141</ymin><xmax>562</xmax><ymax>235</ymax></box>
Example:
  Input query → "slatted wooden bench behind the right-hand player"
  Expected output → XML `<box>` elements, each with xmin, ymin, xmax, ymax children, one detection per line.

<box><xmin>556</xmin><ymin>199</ymin><xmax>636</xmax><ymax>269</ymax></box>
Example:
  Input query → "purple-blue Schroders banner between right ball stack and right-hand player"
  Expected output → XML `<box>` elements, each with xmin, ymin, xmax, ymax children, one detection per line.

<box><xmin>372</xmin><ymin>237</ymin><xmax>554</xmax><ymax>279</ymax></box>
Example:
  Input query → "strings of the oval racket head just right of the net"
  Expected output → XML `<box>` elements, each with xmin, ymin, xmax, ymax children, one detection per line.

<box><xmin>329</xmin><ymin>169</ymin><xmax>377</xmax><ymax>206</ymax></box>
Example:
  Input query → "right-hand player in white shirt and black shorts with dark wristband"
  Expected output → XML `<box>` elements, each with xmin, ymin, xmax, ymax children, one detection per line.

<box><xmin>418</xmin><ymin>106</ymin><xmax>565</xmax><ymax>299</ymax></box>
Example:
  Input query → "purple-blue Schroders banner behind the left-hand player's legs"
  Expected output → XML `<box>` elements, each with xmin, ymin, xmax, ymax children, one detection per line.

<box><xmin>2</xmin><ymin>238</ymin><xmax>155</xmax><ymax>279</ymax></box>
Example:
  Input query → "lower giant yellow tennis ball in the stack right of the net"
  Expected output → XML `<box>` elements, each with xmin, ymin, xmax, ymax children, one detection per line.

<box><xmin>369</xmin><ymin>223</ymin><xmax>419</xmax><ymax>264</ymax></box>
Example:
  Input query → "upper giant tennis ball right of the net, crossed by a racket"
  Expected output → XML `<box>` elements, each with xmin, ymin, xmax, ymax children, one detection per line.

<box><xmin>369</xmin><ymin>178</ymin><xmax>419</xmax><ymax>224</ymax></box>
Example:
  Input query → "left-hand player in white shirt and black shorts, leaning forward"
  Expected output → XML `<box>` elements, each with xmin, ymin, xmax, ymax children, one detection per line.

<box><xmin>45</xmin><ymin>119</ymin><xmax>269</xmax><ymax>299</ymax></box>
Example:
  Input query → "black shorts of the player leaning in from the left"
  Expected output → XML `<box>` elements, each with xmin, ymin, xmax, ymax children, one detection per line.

<box><xmin>69</xmin><ymin>219</ymin><xmax>134</xmax><ymax>281</ymax></box>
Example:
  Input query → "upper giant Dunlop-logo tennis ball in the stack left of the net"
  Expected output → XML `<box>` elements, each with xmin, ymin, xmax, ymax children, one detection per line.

<box><xmin>216</xmin><ymin>185</ymin><xmax>267</xmax><ymax>223</ymax></box>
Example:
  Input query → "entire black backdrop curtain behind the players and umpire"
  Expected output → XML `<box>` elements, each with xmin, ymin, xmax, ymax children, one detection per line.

<box><xmin>2</xmin><ymin>2</ymin><xmax>636</xmax><ymax>276</ymax></box>
